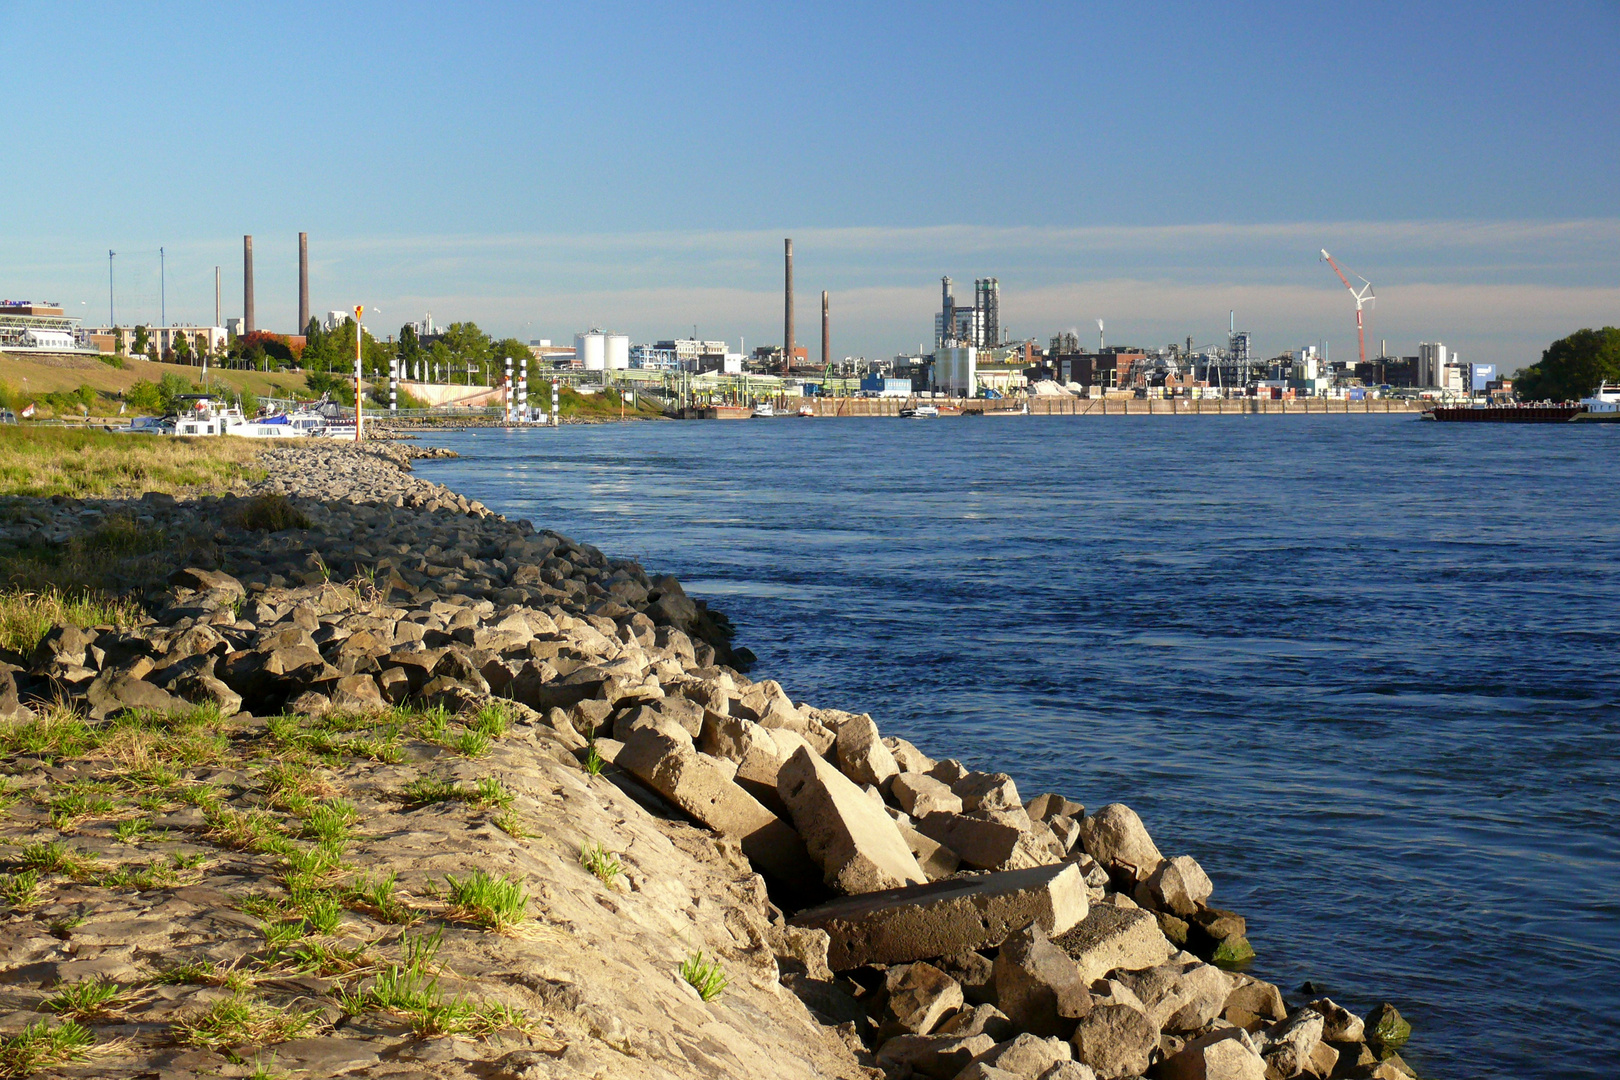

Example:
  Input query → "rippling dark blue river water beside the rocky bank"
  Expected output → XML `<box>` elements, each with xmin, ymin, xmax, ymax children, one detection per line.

<box><xmin>418</xmin><ymin>416</ymin><xmax>1620</xmax><ymax>1080</ymax></box>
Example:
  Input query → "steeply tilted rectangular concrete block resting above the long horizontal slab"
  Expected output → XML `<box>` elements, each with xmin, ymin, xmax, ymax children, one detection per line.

<box><xmin>774</xmin><ymin>746</ymin><xmax>928</xmax><ymax>893</ymax></box>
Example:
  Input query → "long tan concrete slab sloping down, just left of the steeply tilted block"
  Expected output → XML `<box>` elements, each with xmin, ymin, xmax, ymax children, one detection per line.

<box><xmin>618</xmin><ymin>721</ymin><xmax>822</xmax><ymax>895</ymax></box>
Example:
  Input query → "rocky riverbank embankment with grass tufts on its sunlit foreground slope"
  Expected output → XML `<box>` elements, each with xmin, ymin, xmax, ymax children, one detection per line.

<box><xmin>0</xmin><ymin>447</ymin><xmax>1408</xmax><ymax>1080</ymax></box>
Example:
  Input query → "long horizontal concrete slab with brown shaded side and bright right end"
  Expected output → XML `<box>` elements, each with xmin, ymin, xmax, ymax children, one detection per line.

<box><xmin>792</xmin><ymin>866</ymin><xmax>1088</xmax><ymax>973</ymax></box>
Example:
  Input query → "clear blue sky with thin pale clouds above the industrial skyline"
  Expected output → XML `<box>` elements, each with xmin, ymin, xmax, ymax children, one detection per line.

<box><xmin>0</xmin><ymin>0</ymin><xmax>1620</xmax><ymax>369</ymax></box>
